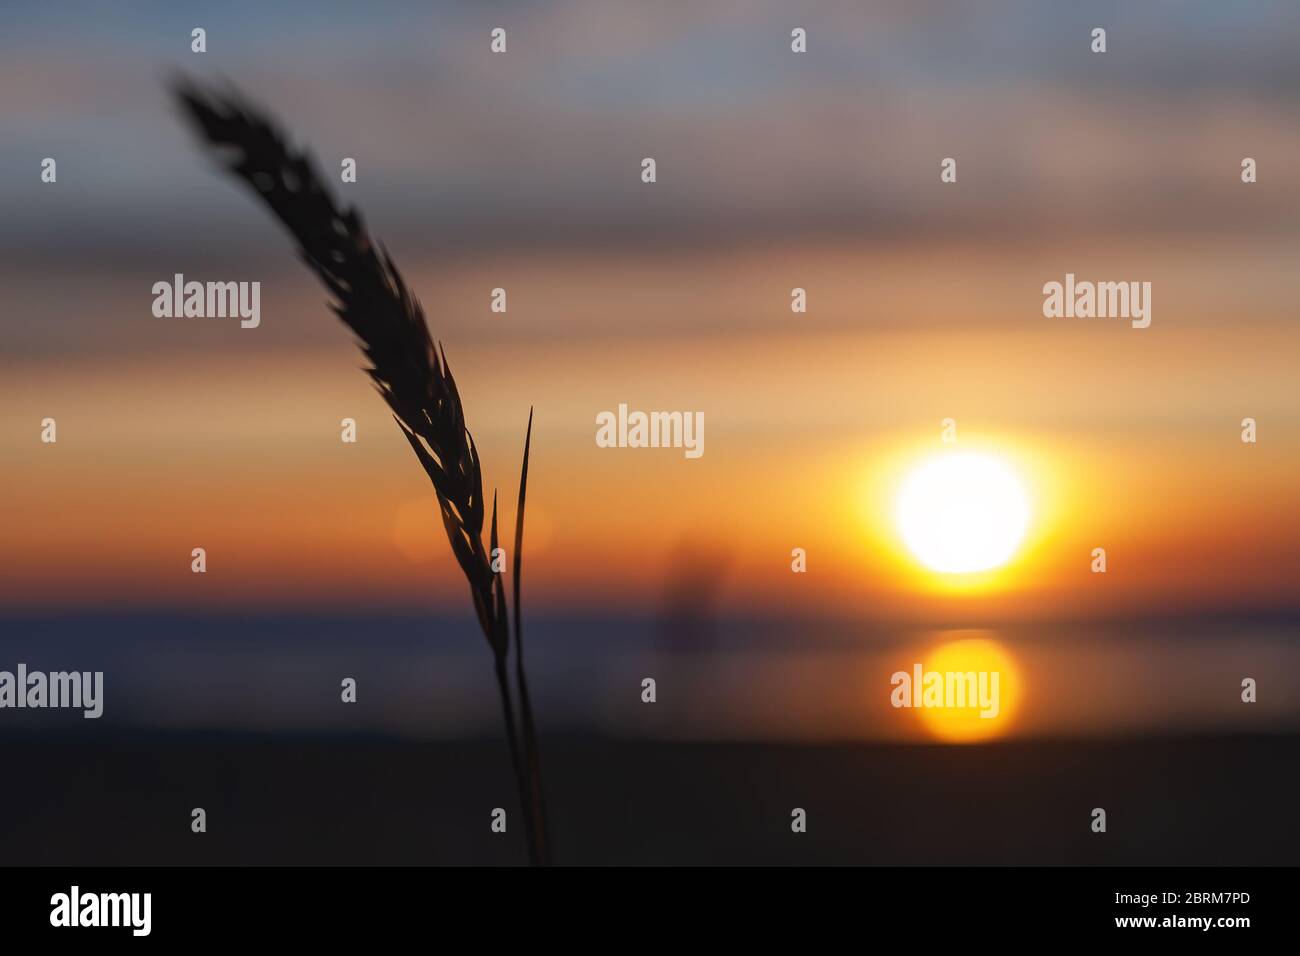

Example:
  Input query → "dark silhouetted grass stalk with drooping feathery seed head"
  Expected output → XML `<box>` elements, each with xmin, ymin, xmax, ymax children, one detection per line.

<box><xmin>174</xmin><ymin>79</ymin><xmax>550</xmax><ymax>865</ymax></box>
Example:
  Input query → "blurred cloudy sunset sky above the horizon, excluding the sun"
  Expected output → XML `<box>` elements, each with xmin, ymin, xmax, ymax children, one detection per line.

<box><xmin>0</xmin><ymin>3</ymin><xmax>1300</xmax><ymax>626</ymax></box>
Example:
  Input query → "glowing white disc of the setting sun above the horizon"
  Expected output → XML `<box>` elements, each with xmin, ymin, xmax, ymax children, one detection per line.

<box><xmin>896</xmin><ymin>453</ymin><xmax>1030</xmax><ymax>574</ymax></box>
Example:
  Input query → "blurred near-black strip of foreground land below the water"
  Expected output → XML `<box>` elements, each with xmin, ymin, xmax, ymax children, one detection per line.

<box><xmin>0</xmin><ymin>734</ymin><xmax>1300</xmax><ymax>865</ymax></box>
